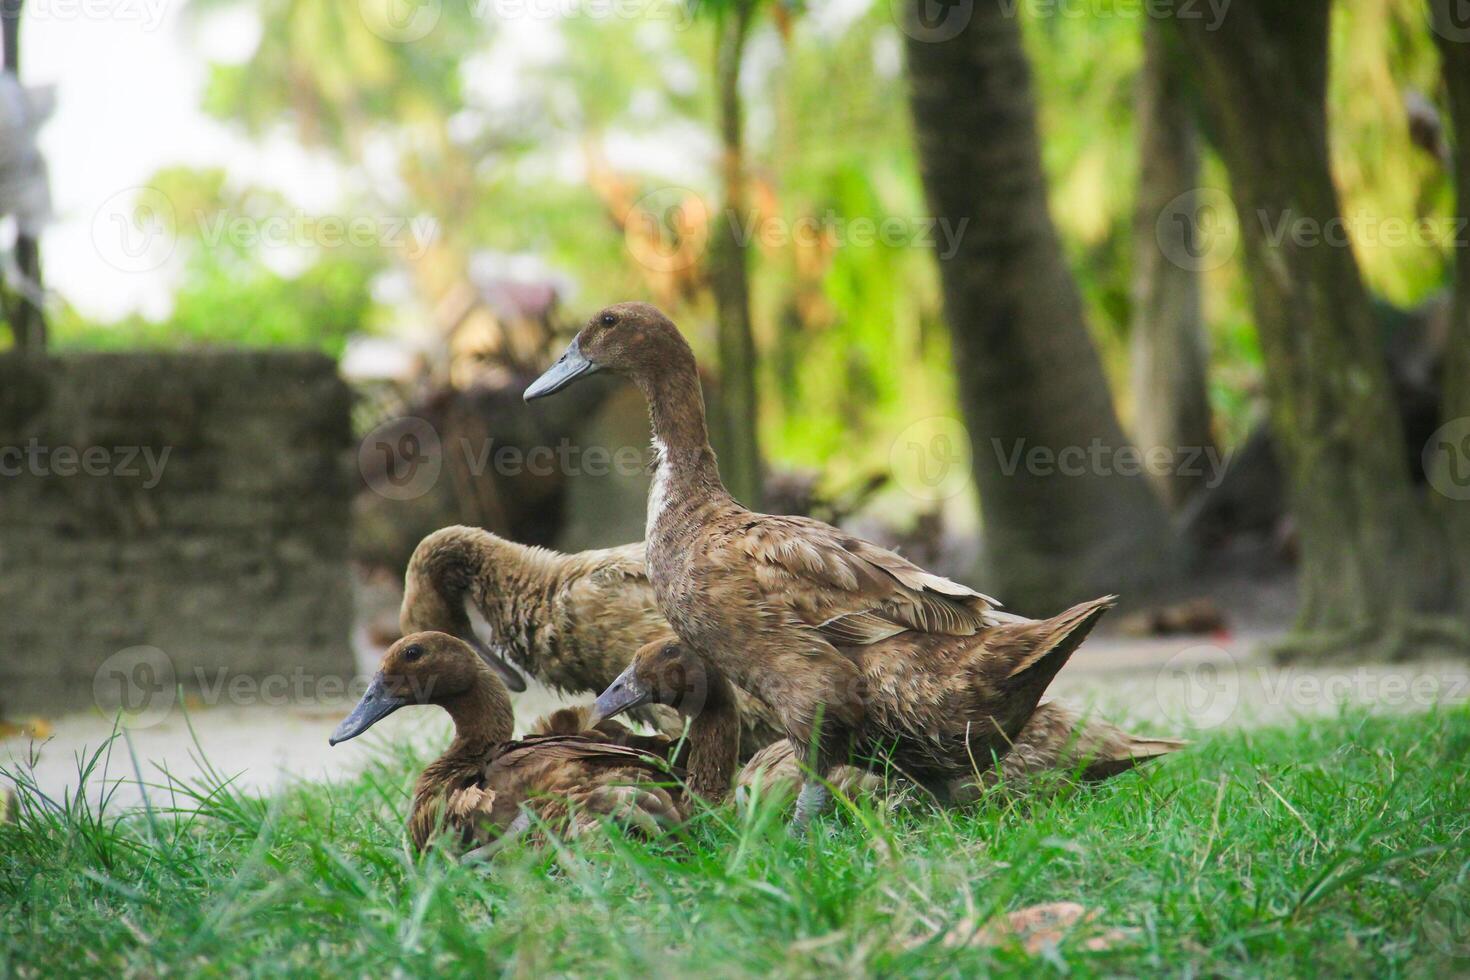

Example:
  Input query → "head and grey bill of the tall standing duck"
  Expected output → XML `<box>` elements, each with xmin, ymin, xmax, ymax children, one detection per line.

<box><xmin>525</xmin><ymin>303</ymin><xmax>694</xmax><ymax>401</ymax></box>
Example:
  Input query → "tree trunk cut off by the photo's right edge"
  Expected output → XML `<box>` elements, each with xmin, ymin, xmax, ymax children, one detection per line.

<box><xmin>1424</xmin><ymin>0</ymin><xmax>1470</xmax><ymax>616</ymax></box>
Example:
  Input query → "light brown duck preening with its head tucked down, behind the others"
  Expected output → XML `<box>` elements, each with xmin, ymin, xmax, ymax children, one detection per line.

<box><xmin>398</xmin><ymin>527</ymin><xmax>784</xmax><ymax>751</ymax></box>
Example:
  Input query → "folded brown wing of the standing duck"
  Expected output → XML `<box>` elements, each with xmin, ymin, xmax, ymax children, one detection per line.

<box><xmin>710</xmin><ymin>516</ymin><xmax>1013</xmax><ymax>646</ymax></box>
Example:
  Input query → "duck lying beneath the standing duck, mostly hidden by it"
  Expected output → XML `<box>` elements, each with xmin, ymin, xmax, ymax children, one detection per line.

<box><xmin>596</xmin><ymin>641</ymin><xmax>1186</xmax><ymax>802</ymax></box>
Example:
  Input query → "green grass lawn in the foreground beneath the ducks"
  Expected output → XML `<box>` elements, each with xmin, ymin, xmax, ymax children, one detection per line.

<box><xmin>0</xmin><ymin>710</ymin><xmax>1470</xmax><ymax>977</ymax></box>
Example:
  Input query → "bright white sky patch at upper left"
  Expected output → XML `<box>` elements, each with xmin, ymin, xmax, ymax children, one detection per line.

<box><xmin>21</xmin><ymin>0</ymin><xmax>338</xmax><ymax>319</ymax></box>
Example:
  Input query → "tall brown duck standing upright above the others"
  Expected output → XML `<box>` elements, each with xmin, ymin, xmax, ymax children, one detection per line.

<box><xmin>525</xmin><ymin>303</ymin><xmax>1116</xmax><ymax>833</ymax></box>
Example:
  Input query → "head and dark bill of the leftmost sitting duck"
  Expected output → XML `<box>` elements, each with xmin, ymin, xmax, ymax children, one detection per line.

<box><xmin>328</xmin><ymin>633</ymin><xmax>496</xmax><ymax>745</ymax></box>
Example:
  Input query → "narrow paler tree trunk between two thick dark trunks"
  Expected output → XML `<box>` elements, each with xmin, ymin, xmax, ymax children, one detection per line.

<box><xmin>1130</xmin><ymin>18</ymin><xmax>1214</xmax><ymax>510</ymax></box>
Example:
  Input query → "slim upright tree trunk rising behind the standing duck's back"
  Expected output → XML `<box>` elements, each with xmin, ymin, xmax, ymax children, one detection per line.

<box><xmin>710</xmin><ymin>0</ymin><xmax>761</xmax><ymax>510</ymax></box>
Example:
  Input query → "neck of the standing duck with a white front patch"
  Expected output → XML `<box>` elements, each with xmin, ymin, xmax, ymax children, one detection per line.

<box><xmin>634</xmin><ymin>359</ymin><xmax>729</xmax><ymax>538</ymax></box>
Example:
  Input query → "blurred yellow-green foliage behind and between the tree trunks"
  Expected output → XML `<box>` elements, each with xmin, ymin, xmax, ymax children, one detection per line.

<box><xmin>80</xmin><ymin>0</ymin><xmax>1452</xmax><ymax>470</ymax></box>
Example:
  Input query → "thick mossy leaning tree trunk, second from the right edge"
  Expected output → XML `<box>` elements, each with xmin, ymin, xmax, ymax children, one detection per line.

<box><xmin>1167</xmin><ymin>0</ymin><xmax>1458</xmax><ymax>658</ymax></box>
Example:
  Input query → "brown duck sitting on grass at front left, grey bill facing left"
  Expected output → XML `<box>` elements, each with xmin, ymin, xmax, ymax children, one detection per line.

<box><xmin>331</xmin><ymin>632</ymin><xmax>681</xmax><ymax>851</ymax></box>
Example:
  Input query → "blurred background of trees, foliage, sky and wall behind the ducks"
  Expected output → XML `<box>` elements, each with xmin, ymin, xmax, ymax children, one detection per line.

<box><xmin>0</xmin><ymin>0</ymin><xmax>1470</xmax><ymax>764</ymax></box>
